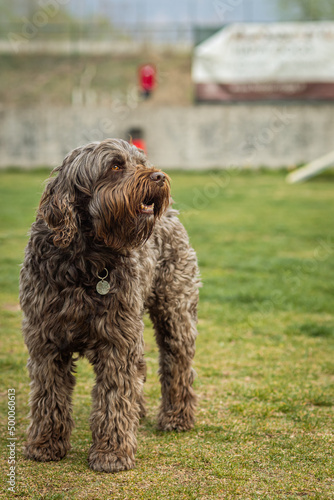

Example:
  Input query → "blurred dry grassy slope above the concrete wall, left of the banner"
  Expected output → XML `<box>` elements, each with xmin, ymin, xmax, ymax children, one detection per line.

<box><xmin>0</xmin><ymin>51</ymin><xmax>192</xmax><ymax>108</ymax></box>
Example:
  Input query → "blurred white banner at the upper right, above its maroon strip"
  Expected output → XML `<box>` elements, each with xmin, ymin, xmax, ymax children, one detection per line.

<box><xmin>192</xmin><ymin>22</ymin><xmax>334</xmax><ymax>85</ymax></box>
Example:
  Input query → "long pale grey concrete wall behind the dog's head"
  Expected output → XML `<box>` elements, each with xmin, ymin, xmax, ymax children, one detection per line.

<box><xmin>0</xmin><ymin>103</ymin><xmax>334</xmax><ymax>169</ymax></box>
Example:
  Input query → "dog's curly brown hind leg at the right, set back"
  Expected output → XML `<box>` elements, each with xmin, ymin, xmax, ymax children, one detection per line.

<box><xmin>148</xmin><ymin>230</ymin><xmax>198</xmax><ymax>431</ymax></box>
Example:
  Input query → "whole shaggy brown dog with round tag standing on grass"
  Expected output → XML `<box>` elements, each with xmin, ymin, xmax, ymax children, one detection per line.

<box><xmin>20</xmin><ymin>139</ymin><xmax>199</xmax><ymax>472</ymax></box>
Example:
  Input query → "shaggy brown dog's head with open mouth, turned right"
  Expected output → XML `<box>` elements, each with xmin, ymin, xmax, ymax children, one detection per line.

<box><xmin>38</xmin><ymin>139</ymin><xmax>170</xmax><ymax>250</ymax></box>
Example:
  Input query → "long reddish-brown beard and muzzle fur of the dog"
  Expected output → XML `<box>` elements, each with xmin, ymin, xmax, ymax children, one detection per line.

<box><xmin>90</xmin><ymin>173</ymin><xmax>170</xmax><ymax>251</ymax></box>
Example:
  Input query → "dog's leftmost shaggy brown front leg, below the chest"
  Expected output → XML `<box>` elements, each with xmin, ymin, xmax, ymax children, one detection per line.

<box><xmin>24</xmin><ymin>349</ymin><xmax>75</xmax><ymax>462</ymax></box>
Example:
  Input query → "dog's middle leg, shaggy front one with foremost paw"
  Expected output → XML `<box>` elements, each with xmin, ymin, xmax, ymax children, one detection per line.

<box><xmin>88</xmin><ymin>335</ymin><xmax>143</xmax><ymax>472</ymax></box>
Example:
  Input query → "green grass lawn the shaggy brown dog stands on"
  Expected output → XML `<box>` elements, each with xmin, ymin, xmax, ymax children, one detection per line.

<box><xmin>0</xmin><ymin>171</ymin><xmax>334</xmax><ymax>500</ymax></box>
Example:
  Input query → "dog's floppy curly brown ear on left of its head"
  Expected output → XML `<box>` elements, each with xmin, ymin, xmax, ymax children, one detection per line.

<box><xmin>38</xmin><ymin>167</ymin><xmax>78</xmax><ymax>248</ymax></box>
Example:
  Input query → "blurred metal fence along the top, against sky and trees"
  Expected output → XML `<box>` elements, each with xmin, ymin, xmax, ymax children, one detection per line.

<box><xmin>0</xmin><ymin>0</ymin><xmax>334</xmax><ymax>43</ymax></box>
